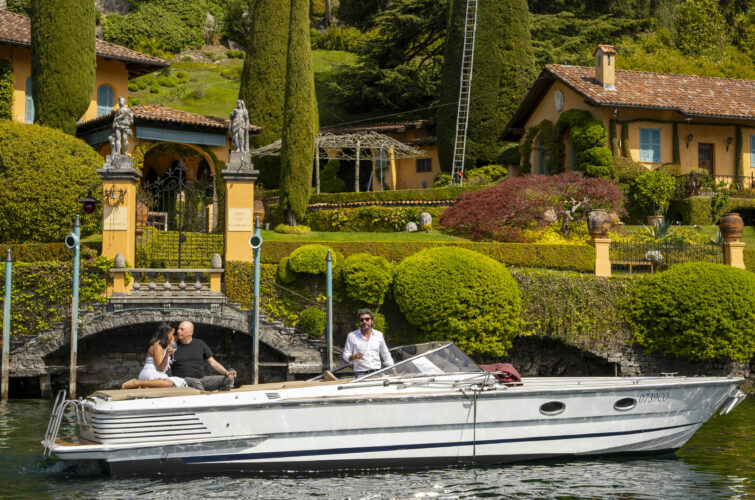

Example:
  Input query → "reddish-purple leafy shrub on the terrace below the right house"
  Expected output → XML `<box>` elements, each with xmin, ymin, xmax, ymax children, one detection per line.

<box><xmin>440</xmin><ymin>172</ymin><xmax>624</xmax><ymax>242</ymax></box>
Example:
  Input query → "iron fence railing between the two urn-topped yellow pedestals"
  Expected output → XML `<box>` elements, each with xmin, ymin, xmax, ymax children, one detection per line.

<box><xmin>609</xmin><ymin>241</ymin><xmax>724</xmax><ymax>272</ymax></box>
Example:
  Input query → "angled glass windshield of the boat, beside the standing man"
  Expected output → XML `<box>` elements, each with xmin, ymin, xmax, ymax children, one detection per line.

<box><xmin>358</xmin><ymin>343</ymin><xmax>482</xmax><ymax>380</ymax></box>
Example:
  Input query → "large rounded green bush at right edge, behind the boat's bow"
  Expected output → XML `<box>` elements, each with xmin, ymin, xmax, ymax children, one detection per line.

<box><xmin>625</xmin><ymin>263</ymin><xmax>755</xmax><ymax>361</ymax></box>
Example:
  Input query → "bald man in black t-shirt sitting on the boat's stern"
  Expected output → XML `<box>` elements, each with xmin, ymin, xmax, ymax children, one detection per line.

<box><xmin>170</xmin><ymin>321</ymin><xmax>236</xmax><ymax>391</ymax></box>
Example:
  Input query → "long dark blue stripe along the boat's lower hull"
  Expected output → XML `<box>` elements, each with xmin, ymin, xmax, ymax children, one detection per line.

<box><xmin>181</xmin><ymin>423</ymin><xmax>699</xmax><ymax>463</ymax></box>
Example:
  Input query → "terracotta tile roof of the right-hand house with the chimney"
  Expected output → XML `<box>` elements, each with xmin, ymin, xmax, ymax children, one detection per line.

<box><xmin>544</xmin><ymin>64</ymin><xmax>755</xmax><ymax>120</ymax></box>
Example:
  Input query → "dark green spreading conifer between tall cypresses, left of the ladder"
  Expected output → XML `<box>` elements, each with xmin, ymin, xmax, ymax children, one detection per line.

<box><xmin>329</xmin><ymin>0</ymin><xmax>448</xmax><ymax>112</ymax></box>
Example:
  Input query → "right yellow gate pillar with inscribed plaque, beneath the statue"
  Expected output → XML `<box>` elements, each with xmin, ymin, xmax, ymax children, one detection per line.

<box><xmin>221</xmin><ymin>151</ymin><xmax>259</xmax><ymax>262</ymax></box>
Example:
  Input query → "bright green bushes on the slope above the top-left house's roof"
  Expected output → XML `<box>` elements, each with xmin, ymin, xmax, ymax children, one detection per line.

<box><xmin>102</xmin><ymin>0</ymin><xmax>206</xmax><ymax>57</ymax></box>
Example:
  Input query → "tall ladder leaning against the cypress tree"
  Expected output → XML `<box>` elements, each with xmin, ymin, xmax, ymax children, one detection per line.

<box><xmin>451</xmin><ymin>0</ymin><xmax>477</xmax><ymax>186</ymax></box>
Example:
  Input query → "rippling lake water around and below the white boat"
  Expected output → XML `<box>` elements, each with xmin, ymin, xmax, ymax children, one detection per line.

<box><xmin>0</xmin><ymin>396</ymin><xmax>755</xmax><ymax>500</ymax></box>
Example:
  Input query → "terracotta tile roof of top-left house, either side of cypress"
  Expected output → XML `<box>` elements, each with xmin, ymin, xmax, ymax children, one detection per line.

<box><xmin>0</xmin><ymin>10</ymin><xmax>170</xmax><ymax>74</ymax></box>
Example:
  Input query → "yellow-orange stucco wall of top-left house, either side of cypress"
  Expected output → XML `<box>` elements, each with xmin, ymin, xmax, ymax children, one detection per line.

<box><xmin>0</xmin><ymin>45</ymin><xmax>128</xmax><ymax>122</ymax></box>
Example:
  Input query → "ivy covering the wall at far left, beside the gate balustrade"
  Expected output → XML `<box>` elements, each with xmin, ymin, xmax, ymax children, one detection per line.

<box><xmin>0</xmin><ymin>251</ymin><xmax>113</xmax><ymax>340</ymax></box>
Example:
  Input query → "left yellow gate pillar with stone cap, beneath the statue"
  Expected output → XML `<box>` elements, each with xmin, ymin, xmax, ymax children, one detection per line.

<box><xmin>97</xmin><ymin>162</ymin><xmax>142</xmax><ymax>266</ymax></box>
